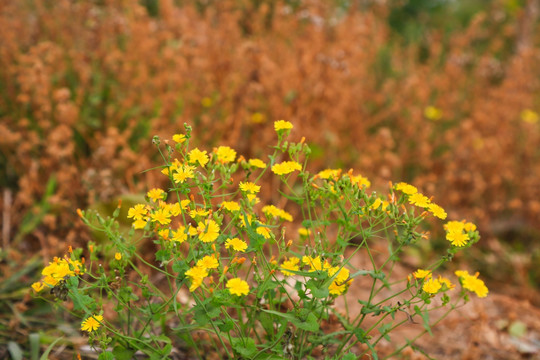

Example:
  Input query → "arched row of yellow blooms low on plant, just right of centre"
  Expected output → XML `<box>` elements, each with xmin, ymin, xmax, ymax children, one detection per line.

<box><xmin>280</xmin><ymin>256</ymin><xmax>353</xmax><ymax>296</ymax></box>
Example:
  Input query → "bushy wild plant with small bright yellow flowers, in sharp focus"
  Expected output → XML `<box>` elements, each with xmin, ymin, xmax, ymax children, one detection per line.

<box><xmin>33</xmin><ymin>120</ymin><xmax>488</xmax><ymax>359</ymax></box>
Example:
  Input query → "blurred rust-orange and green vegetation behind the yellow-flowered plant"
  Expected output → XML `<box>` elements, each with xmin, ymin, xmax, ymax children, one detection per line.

<box><xmin>0</xmin><ymin>0</ymin><xmax>540</xmax><ymax>358</ymax></box>
